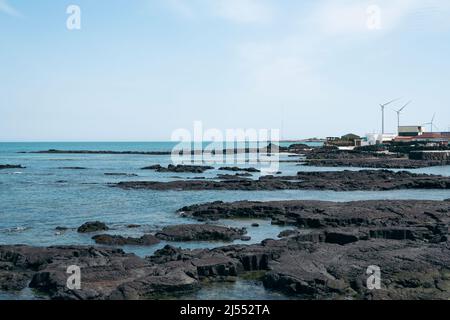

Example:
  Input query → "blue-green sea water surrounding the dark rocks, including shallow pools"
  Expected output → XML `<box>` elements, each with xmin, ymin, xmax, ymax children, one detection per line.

<box><xmin>0</xmin><ymin>142</ymin><xmax>450</xmax><ymax>299</ymax></box>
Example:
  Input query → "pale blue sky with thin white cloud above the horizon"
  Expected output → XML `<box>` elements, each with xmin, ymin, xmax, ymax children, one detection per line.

<box><xmin>0</xmin><ymin>0</ymin><xmax>450</xmax><ymax>141</ymax></box>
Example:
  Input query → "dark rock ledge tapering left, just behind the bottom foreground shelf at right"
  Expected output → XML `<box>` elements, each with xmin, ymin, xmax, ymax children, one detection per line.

<box><xmin>179</xmin><ymin>200</ymin><xmax>450</xmax><ymax>244</ymax></box>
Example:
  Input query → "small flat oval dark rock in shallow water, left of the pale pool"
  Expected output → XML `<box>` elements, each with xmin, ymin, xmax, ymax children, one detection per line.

<box><xmin>155</xmin><ymin>224</ymin><xmax>246</xmax><ymax>241</ymax></box>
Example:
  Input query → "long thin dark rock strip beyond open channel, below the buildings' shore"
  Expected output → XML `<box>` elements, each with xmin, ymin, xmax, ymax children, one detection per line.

<box><xmin>112</xmin><ymin>170</ymin><xmax>450</xmax><ymax>191</ymax></box>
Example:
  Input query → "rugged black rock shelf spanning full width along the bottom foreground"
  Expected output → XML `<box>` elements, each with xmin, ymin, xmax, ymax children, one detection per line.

<box><xmin>0</xmin><ymin>235</ymin><xmax>450</xmax><ymax>300</ymax></box>
